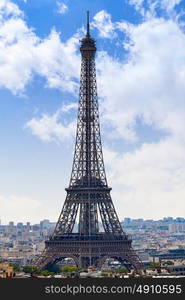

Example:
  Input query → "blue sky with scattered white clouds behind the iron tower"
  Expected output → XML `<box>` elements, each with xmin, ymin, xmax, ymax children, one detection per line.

<box><xmin>0</xmin><ymin>0</ymin><xmax>185</xmax><ymax>224</ymax></box>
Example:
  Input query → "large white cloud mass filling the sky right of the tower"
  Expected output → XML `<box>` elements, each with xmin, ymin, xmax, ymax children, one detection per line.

<box><xmin>94</xmin><ymin>9</ymin><xmax>185</xmax><ymax>218</ymax></box>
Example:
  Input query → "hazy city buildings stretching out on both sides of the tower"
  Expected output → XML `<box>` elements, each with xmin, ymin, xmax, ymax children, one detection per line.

<box><xmin>0</xmin><ymin>218</ymin><xmax>185</xmax><ymax>266</ymax></box>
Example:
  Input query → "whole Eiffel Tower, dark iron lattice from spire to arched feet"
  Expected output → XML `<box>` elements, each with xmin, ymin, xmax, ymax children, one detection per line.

<box><xmin>36</xmin><ymin>12</ymin><xmax>142</xmax><ymax>270</ymax></box>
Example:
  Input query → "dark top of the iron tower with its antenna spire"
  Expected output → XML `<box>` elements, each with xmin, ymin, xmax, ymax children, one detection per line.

<box><xmin>80</xmin><ymin>11</ymin><xmax>96</xmax><ymax>57</ymax></box>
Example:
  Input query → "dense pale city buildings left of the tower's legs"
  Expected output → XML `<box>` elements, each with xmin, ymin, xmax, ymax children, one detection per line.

<box><xmin>0</xmin><ymin>220</ymin><xmax>55</xmax><ymax>266</ymax></box>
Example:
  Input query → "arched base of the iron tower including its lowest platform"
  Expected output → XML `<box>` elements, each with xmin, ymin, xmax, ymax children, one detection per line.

<box><xmin>36</xmin><ymin>233</ymin><xmax>142</xmax><ymax>270</ymax></box>
